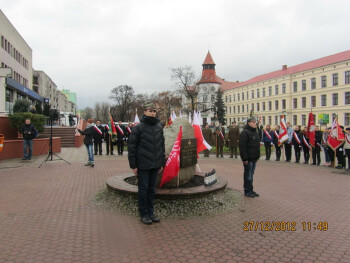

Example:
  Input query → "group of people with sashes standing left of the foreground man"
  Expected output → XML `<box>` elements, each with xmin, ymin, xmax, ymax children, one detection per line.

<box><xmin>77</xmin><ymin>118</ymin><xmax>133</xmax><ymax>167</ymax></box>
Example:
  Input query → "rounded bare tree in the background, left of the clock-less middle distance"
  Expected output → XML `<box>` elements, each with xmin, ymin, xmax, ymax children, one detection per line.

<box><xmin>109</xmin><ymin>85</ymin><xmax>136</xmax><ymax>121</ymax></box>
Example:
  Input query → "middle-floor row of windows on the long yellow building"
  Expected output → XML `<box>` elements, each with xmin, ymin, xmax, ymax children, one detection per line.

<box><xmin>226</xmin><ymin>92</ymin><xmax>350</xmax><ymax>114</ymax></box>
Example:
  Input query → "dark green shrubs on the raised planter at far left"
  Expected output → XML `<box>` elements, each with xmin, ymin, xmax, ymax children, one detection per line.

<box><xmin>9</xmin><ymin>112</ymin><xmax>46</xmax><ymax>133</ymax></box>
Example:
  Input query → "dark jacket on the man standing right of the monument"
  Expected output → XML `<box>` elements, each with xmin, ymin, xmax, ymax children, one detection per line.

<box><xmin>239</xmin><ymin>124</ymin><xmax>260</xmax><ymax>162</ymax></box>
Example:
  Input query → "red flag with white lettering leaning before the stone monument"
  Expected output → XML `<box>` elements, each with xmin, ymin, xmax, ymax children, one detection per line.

<box><xmin>160</xmin><ymin>126</ymin><xmax>182</xmax><ymax>187</ymax></box>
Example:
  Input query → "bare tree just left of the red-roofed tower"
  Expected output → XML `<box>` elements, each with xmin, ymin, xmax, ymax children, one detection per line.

<box><xmin>170</xmin><ymin>65</ymin><xmax>198</xmax><ymax>112</ymax></box>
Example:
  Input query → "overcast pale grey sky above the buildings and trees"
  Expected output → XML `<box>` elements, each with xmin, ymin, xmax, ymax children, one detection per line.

<box><xmin>0</xmin><ymin>0</ymin><xmax>350</xmax><ymax>108</ymax></box>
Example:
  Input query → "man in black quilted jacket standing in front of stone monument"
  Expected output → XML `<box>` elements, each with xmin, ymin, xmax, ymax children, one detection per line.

<box><xmin>128</xmin><ymin>103</ymin><xmax>165</xmax><ymax>224</ymax></box>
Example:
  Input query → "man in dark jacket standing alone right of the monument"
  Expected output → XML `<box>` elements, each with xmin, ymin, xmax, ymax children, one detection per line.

<box><xmin>239</xmin><ymin>117</ymin><xmax>260</xmax><ymax>197</ymax></box>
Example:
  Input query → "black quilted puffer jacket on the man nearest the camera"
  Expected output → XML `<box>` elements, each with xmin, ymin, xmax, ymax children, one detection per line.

<box><xmin>128</xmin><ymin>115</ymin><xmax>165</xmax><ymax>170</ymax></box>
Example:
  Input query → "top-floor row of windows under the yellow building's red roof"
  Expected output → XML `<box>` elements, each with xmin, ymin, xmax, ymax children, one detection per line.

<box><xmin>225</xmin><ymin>71</ymin><xmax>350</xmax><ymax>103</ymax></box>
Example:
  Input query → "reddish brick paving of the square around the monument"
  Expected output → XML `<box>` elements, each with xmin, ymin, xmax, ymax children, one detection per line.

<box><xmin>0</xmin><ymin>147</ymin><xmax>350</xmax><ymax>263</ymax></box>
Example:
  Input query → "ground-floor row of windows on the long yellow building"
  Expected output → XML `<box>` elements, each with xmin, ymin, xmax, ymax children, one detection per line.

<box><xmin>226</xmin><ymin>113</ymin><xmax>350</xmax><ymax>126</ymax></box>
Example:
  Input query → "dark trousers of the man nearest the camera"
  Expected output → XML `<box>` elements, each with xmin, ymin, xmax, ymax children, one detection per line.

<box><xmin>137</xmin><ymin>169</ymin><xmax>159</xmax><ymax>217</ymax></box>
